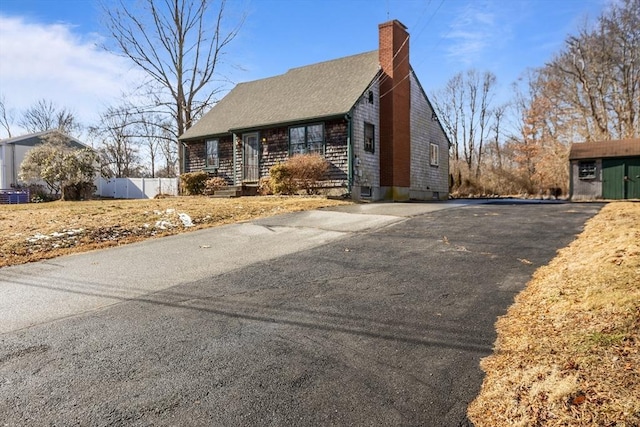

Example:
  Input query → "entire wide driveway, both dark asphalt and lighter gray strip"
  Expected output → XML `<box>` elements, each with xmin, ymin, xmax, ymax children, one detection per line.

<box><xmin>0</xmin><ymin>203</ymin><xmax>600</xmax><ymax>426</ymax></box>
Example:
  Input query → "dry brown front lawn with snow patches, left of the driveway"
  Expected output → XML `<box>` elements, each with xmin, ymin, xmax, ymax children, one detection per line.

<box><xmin>0</xmin><ymin>196</ymin><xmax>349</xmax><ymax>267</ymax></box>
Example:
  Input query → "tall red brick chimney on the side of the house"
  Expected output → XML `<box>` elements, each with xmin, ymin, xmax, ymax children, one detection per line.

<box><xmin>378</xmin><ymin>20</ymin><xmax>411</xmax><ymax>200</ymax></box>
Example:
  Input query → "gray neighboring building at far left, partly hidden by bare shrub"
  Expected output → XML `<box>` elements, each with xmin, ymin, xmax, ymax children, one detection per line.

<box><xmin>0</xmin><ymin>130</ymin><xmax>91</xmax><ymax>189</ymax></box>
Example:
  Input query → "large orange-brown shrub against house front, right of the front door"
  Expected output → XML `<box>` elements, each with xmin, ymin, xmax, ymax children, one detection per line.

<box><xmin>269</xmin><ymin>154</ymin><xmax>329</xmax><ymax>194</ymax></box>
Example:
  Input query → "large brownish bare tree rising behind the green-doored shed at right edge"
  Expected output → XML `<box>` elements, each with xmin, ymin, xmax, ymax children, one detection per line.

<box><xmin>538</xmin><ymin>0</ymin><xmax>640</xmax><ymax>141</ymax></box>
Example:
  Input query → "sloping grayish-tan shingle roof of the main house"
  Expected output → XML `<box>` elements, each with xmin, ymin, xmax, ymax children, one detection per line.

<box><xmin>180</xmin><ymin>50</ymin><xmax>380</xmax><ymax>140</ymax></box>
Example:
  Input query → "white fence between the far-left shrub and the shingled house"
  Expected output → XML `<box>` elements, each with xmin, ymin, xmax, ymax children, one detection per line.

<box><xmin>96</xmin><ymin>178</ymin><xmax>178</xmax><ymax>199</ymax></box>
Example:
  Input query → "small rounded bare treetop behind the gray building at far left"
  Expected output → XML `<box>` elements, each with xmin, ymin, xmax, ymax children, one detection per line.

<box><xmin>18</xmin><ymin>99</ymin><xmax>82</xmax><ymax>135</ymax></box>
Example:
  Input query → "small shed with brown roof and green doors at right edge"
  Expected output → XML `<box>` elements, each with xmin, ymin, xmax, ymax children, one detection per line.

<box><xmin>569</xmin><ymin>138</ymin><xmax>640</xmax><ymax>200</ymax></box>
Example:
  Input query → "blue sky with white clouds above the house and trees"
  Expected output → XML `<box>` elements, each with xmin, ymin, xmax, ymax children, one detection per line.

<box><xmin>0</xmin><ymin>0</ymin><xmax>611</xmax><ymax>137</ymax></box>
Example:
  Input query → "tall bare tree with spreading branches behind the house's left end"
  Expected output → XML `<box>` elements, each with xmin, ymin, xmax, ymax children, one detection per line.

<box><xmin>103</xmin><ymin>0</ymin><xmax>244</xmax><ymax>174</ymax></box>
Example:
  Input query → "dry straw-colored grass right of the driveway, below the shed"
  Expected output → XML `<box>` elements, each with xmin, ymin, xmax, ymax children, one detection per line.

<box><xmin>468</xmin><ymin>202</ymin><xmax>640</xmax><ymax>427</ymax></box>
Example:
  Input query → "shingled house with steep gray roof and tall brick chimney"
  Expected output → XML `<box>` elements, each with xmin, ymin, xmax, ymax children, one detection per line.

<box><xmin>180</xmin><ymin>20</ymin><xmax>449</xmax><ymax>201</ymax></box>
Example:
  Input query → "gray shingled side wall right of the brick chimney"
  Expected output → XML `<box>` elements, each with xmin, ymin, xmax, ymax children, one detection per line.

<box><xmin>410</xmin><ymin>74</ymin><xmax>449</xmax><ymax>200</ymax></box>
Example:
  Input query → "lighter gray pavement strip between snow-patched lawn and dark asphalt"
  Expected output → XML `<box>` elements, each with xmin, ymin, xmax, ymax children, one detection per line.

<box><xmin>0</xmin><ymin>202</ymin><xmax>471</xmax><ymax>334</ymax></box>
